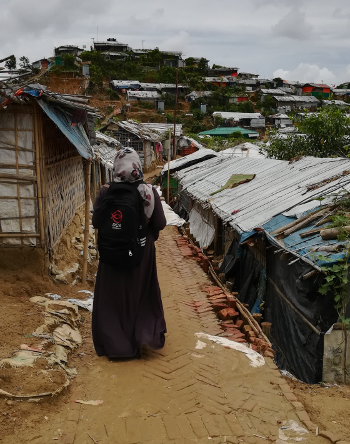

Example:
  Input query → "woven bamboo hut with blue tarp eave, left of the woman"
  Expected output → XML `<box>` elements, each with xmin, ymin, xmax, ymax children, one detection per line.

<box><xmin>0</xmin><ymin>84</ymin><xmax>96</xmax><ymax>279</ymax></box>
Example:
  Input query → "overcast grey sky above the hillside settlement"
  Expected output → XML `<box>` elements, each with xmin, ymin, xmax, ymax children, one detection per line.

<box><xmin>0</xmin><ymin>0</ymin><xmax>350</xmax><ymax>85</ymax></box>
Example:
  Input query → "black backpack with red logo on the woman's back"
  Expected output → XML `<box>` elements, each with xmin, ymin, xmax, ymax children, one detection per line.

<box><xmin>96</xmin><ymin>182</ymin><xmax>147</xmax><ymax>270</ymax></box>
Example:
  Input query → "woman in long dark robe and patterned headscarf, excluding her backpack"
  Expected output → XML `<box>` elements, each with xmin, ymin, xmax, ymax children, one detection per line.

<box><xmin>92</xmin><ymin>148</ymin><xmax>166</xmax><ymax>359</ymax></box>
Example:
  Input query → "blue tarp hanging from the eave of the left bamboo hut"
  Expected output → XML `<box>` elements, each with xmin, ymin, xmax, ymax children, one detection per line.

<box><xmin>37</xmin><ymin>99</ymin><xmax>93</xmax><ymax>159</ymax></box>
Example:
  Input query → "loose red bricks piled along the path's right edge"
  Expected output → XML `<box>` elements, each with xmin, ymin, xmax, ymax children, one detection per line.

<box><xmin>176</xmin><ymin>236</ymin><xmax>274</xmax><ymax>358</ymax></box>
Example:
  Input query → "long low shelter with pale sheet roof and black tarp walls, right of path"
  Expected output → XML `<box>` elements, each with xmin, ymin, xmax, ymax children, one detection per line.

<box><xmin>172</xmin><ymin>152</ymin><xmax>350</xmax><ymax>383</ymax></box>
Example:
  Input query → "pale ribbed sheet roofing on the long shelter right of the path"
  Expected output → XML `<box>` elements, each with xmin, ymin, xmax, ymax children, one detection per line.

<box><xmin>176</xmin><ymin>156</ymin><xmax>350</xmax><ymax>232</ymax></box>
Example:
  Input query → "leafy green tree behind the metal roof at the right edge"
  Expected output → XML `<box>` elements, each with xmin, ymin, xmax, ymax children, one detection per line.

<box><xmin>265</xmin><ymin>105</ymin><xmax>350</xmax><ymax>160</ymax></box>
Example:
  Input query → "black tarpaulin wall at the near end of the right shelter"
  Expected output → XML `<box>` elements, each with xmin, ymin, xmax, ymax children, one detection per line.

<box><xmin>263</xmin><ymin>248</ymin><xmax>338</xmax><ymax>383</ymax></box>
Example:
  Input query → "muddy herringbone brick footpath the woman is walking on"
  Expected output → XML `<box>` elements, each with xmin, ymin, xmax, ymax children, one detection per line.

<box><xmin>2</xmin><ymin>227</ymin><xmax>340</xmax><ymax>444</ymax></box>
